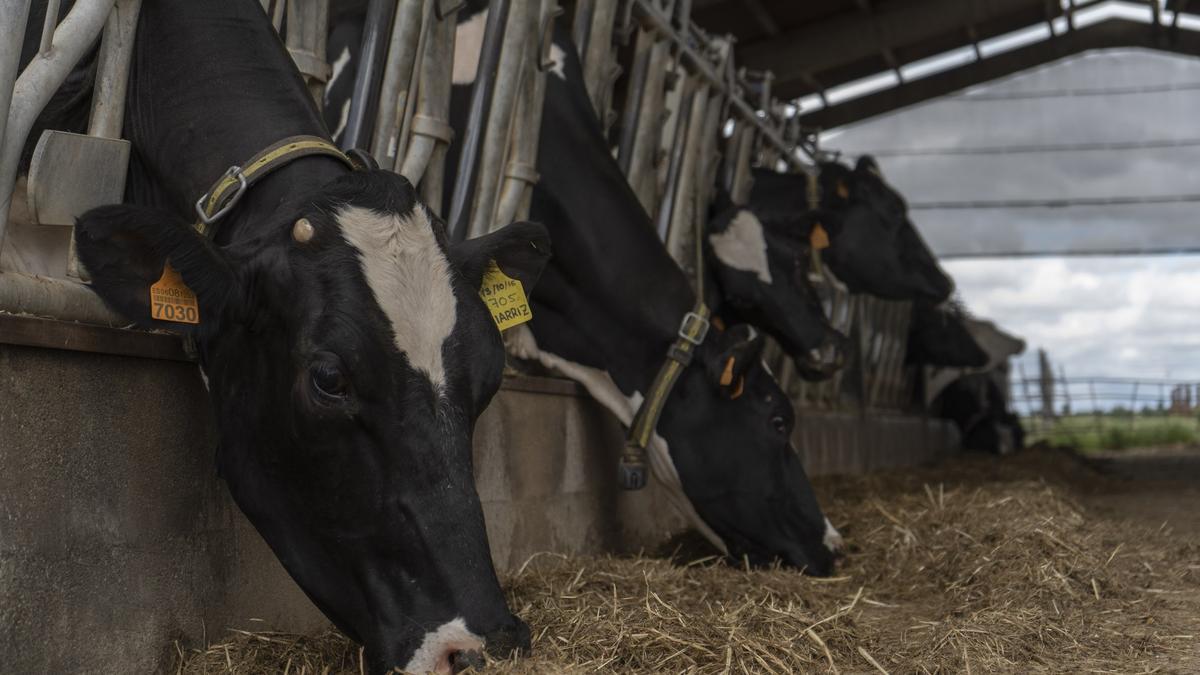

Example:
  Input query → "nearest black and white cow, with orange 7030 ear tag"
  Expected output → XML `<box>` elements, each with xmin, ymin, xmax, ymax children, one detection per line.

<box><xmin>26</xmin><ymin>0</ymin><xmax>548</xmax><ymax>673</ymax></box>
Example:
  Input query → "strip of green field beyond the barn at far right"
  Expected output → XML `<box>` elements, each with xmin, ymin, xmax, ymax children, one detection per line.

<box><xmin>1021</xmin><ymin>414</ymin><xmax>1200</xmax><ymax>452</ymax></box>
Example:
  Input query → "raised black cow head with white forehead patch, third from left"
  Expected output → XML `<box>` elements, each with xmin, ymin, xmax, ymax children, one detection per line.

<box><xmin>707</xmin><ymin>207</ymin><xmax>848</xmax><ymax>380</ymax></box>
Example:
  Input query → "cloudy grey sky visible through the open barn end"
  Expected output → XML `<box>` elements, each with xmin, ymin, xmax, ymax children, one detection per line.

<box><xmin>822</xmin><ymin>49</ymin><xmax>1200</xmax><ymax>382</ymax></box>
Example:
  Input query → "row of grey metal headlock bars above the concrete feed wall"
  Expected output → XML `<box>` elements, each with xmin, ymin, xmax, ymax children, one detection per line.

<box><xmin>0</xmin><ymin>0</ymin><xmax>914</xmax><ymax>408</ymax></box>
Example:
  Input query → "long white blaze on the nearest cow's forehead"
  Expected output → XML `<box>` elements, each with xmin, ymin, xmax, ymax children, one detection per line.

<box><xmin>337</xmin><ymin>204</ymin><xmax>458</xmax><ymax>392</ymax></box>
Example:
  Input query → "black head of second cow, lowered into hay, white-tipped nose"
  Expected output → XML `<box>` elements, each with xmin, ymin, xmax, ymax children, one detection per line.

<box><xmin>659</xmin><ymin>324</ymin><xmax>840</xmax><ymax>575</ymax></box>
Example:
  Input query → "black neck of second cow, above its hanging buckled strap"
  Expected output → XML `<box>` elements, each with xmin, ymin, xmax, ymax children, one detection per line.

<box><xmin>534</xmin><ymin>31</ymin><xmax>695</xmax><ymax>393</ymax></box>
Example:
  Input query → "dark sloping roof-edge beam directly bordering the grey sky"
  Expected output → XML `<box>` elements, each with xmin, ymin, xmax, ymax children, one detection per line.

<box><xmin>800</xmin><ymin>19</ymin><xmax>1200</xmax><ymax>129</ymax></box>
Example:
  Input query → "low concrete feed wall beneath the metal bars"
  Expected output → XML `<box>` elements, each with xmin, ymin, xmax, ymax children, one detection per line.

<box><xmin>0</xmin><ymin>316</ymin><xmax>955</xmax><ymax>674</ymax></box>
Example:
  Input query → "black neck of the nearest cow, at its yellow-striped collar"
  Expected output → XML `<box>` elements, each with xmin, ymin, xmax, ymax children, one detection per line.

<box><xmin>126</xmin><ymin>0</ymin><xmax>349</xmax><ymax>241</ymax></box>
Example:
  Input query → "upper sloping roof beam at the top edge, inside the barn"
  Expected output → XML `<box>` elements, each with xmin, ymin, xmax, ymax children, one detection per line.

<box><xmin>737</xmin><ymin>0</ymin><xmax>1056</xmax><ymax>96</ymax></box>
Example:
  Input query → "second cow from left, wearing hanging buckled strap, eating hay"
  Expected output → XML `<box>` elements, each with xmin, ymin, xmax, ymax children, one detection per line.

<box><xmin>511</xmin><ymin>19</ymin><xmax>840</xmax><ymax>574</ymax></box>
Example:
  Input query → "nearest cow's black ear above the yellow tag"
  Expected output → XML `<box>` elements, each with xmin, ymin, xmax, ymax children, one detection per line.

<box><xmin>450</xmin><ymin>221</ymin><xmax>551</xmax><ymax>293</ymax></box>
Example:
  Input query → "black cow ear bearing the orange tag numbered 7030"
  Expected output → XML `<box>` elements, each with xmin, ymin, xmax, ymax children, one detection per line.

<box><xmin>74</xmin><ymin>204</ymin><xmax>238</xmax><ymax>334</ymax></box>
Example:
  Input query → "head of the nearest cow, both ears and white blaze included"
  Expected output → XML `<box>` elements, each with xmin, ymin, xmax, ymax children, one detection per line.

<box><xmin>76</xmin><ymin>171</ymin><xmax>550</xmax><ymax>673</ymax></box>
